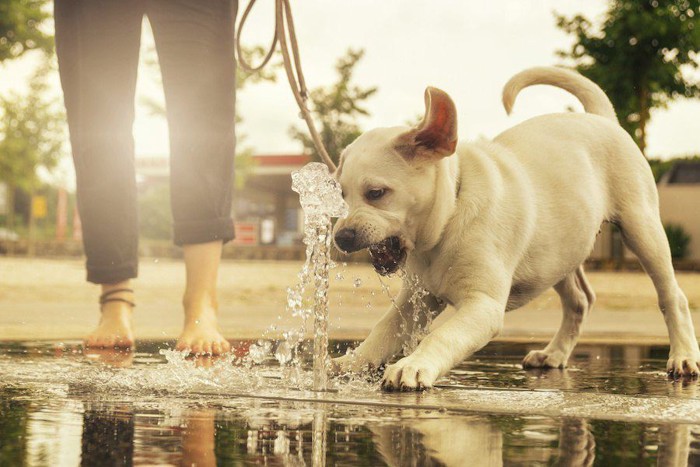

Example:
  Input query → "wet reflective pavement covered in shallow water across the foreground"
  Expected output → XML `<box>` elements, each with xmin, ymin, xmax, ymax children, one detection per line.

<box><xmin>0</xmin><ymin>341</ymin><xmax>700</xmax><ymax>466</ymax></box>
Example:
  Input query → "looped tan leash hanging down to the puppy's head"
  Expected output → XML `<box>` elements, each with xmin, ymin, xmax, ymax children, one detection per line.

<box><xmin>236</xmin><ymin>0</ymin><xmax>336</xmax><ymax>172</ymax></box>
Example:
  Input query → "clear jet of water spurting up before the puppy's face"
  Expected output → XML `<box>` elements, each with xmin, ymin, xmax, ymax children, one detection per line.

<box><xmin>288</xmin><ymin>162</ymin><xmax>348</xmax><ymax>391</ymax></box>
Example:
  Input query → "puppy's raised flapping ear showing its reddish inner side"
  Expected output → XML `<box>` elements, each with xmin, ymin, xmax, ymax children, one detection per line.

<box><xmin>397</xmin><ymin>87</ymin><xmax>457</xmax><ymax>159</ymax></box>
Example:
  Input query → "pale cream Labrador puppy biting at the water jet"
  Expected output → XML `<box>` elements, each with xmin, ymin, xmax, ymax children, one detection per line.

<box><xmin>335</xmin><ymin>68</ymin><xmax>700</xmax><ymax>390</ymax></box>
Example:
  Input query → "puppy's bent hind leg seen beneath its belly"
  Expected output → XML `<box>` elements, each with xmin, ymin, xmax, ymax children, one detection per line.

<box><xmin>523</xmin><ymin>266</ymin><xmax>595</xmax><ymax>368</ymax></box>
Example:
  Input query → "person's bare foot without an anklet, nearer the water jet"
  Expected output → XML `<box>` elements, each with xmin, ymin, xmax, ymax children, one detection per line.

<box><xmin>175</xmin><ymin>303</ymin><xmax>231</xmax><ymax>355</ymax></box>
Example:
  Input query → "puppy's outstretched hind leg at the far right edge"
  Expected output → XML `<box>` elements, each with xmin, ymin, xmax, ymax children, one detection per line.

<box><xmin>618</xmin><ymin>209</ymin><xmax>700</xmax><ymax>377</ymax></box>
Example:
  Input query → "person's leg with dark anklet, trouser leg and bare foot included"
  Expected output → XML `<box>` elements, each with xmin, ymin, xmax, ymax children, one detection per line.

<box><xmin>54</xmin><ymin>0</ymin><xmax>143</xmax><ymax>347</ymax></box>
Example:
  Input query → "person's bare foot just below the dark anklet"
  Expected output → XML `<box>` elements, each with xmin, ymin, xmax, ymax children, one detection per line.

<box><xmin>84</xmin><ymin>302</ymin><xmax>134</xmax><ymax>349</ymax></box>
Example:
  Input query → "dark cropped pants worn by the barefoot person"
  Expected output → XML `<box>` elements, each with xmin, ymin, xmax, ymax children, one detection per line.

<box><xmin>55</xmin><ymin>0</ymin><xmax>238</xmax><ymax>284</ymax></box>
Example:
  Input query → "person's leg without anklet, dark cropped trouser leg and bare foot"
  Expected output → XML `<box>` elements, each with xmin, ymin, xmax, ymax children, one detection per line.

<box><xmin>147</xmin><ymin>0</ymin><xmax>237</xmax><ymax>354</ymax></box>
